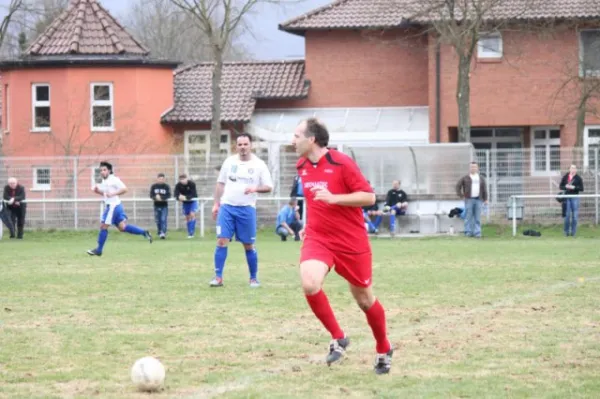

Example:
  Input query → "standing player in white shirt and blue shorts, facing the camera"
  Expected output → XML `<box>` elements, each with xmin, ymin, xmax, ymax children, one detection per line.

<box><xmin>210</xmin><ymin>133</ymin><xmax>273</xmax><ymax>288</ymax></box>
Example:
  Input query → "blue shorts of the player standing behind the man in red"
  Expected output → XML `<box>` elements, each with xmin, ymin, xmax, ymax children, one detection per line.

<box><xmin>217</xmin><ymin>205</ymin><xmax>256</xmax><ymax>244</ymax></box>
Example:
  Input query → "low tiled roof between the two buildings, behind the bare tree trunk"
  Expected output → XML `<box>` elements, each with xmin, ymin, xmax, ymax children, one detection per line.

<box><xmin>162</xmin><ymin>61</ymin><xmax>309</xmax><ymax>123</ymax></box>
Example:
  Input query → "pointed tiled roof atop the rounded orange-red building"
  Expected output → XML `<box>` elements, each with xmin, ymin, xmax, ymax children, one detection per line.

<box><xmin>25</xmin><ymin>0</ymin><xmax>149</xmax><ymax>56</ymax></box>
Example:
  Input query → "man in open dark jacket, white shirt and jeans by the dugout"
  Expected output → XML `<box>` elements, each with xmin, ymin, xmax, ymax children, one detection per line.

<box><xmin>456</xmin><ymin>162</ymin><xmax>488</xmax><ymax>237</ymax></box>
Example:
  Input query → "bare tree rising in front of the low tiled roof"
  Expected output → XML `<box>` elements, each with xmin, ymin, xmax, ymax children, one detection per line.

<box><xmin>169</xmin><ymin>0</ymin><xmax>281</xmax><ymax>154</ymax></box>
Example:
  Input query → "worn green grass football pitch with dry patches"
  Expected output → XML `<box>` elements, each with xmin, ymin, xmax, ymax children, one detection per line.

<box><xmin>0</xmin><ymin>230</ymin><xmax>600</xmax><ymax>398</ymax></box>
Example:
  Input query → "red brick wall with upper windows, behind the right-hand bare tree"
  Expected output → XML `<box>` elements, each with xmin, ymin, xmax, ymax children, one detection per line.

<box><xmin>429</xmin><ymin>29</ymin><xmax>599</xmax><ymax>146</ymax></box>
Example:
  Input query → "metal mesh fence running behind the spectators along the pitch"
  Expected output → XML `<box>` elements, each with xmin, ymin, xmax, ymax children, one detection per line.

<box><xmin>0</xmin><ymin>144</ymin><xmax>600</xmax><ymax>231</ymax></box>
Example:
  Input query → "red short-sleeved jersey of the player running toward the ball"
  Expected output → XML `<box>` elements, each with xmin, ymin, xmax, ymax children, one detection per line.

<box><xmin>296</xmin><ymin>150</ymin><xmax>373</xmax><ymax>254</ymax></box>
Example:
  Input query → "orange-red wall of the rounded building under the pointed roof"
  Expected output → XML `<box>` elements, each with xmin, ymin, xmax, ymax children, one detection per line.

<box><xmin>1</xmin><ymin>67</ymin><xmax>173</xmax><ymax>156</ymax></box>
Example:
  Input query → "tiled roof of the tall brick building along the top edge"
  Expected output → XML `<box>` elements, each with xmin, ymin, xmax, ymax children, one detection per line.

<box><xmin>279</xmin><ymin>0</ymin><xmax>600</xmax><ymax>34</ymax></box>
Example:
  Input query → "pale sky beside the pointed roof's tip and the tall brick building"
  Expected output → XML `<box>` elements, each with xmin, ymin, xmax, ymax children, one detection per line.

<box><xmin>100</xmin><ymin>0</ymin><xmax>333</xmax><ymax>60</ymax></box>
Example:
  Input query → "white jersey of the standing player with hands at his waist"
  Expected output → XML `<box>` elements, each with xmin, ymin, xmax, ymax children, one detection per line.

<box><xmin>217</xmin><ymin>154</ymin><xmax>273</xmax><ymax>207</ymax></box>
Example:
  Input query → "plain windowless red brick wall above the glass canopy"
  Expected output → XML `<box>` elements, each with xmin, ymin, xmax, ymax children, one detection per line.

<box><xmin>292</xmin><ymin>30</ymin><xmax>427</xmax><ymax>107</ymax></box>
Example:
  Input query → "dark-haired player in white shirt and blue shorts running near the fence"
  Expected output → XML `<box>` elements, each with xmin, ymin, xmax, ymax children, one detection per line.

<box><xmin>87</xmin><ymin>161</ymin><xmax>152</xmax><ymax>256</ymax></box>
